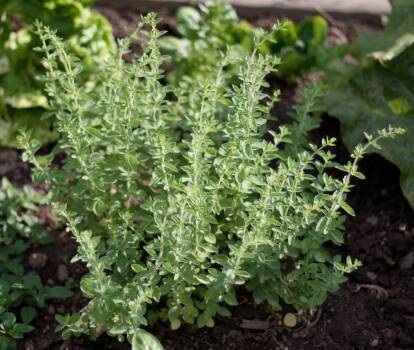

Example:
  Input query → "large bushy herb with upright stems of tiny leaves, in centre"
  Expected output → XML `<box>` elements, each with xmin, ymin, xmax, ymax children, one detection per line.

<box><xmin>20</xmin><ymin>15</ymin><xmax>401</xmax><ymax>349</ymax></box>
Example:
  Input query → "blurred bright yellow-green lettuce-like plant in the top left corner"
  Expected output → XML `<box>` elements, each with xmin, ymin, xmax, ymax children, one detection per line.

<box><xmin>0</xmin><ymin>0</ymin><xmax>113</xmax><ymax>145</ymax></box>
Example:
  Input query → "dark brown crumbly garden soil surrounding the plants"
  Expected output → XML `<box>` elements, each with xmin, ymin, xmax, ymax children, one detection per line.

<box><xmin>0</xmin><ymin>7</ymin><xmax>414</xmax><ymax>350</ymax></box>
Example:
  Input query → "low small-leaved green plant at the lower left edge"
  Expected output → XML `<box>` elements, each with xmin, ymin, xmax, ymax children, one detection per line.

<box><xmin>0</xmin><ymin>178</ymin><xmax>71</xmax><ymax>350</ymax></box>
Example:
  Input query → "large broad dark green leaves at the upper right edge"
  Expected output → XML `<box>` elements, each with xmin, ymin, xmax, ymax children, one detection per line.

<box><xmin>325</xmin><ymin>0</ymin><xmax>414</xmax><ymax>206</ymax></box>
